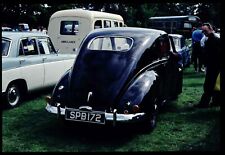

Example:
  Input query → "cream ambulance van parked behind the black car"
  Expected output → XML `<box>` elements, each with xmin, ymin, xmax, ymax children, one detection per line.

<box><xmin>48</xmin><ymin>9</ymin><xmax>124</xmax><ymax>54</ymax></box>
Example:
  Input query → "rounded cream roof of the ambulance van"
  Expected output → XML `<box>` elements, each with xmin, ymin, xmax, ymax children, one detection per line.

<box><xmin>50</xmin><ymin>9</ymin><xmax>123</xmax><ymax>21</ymax></box>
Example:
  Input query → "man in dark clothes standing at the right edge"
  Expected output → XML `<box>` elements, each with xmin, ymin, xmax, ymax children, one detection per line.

<box><xmin>194</xmin><ymin>23</ymin><xmax>221</xmax><ymax>108</ymax></box>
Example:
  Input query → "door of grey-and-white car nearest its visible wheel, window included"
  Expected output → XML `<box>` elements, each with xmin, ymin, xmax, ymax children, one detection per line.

<box><xmin>18</xmin><ymin>38</ymin><xmax>44</xmax><ymax>90</ymax></box>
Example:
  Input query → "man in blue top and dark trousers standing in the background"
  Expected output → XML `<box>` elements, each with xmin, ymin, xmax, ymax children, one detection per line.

<box><xmin>192</xmin><ymin>26</ymin><xmax>204</xmax><ymax>72</ymax></box>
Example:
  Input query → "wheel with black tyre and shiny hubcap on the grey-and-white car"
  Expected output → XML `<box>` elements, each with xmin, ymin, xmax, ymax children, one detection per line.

<box><xmin>6</xmin><ymin>84</ymin><xmax>22</xmax><ymax>108</ymax></box>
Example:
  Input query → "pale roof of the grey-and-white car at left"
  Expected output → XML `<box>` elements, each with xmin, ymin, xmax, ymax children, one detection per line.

<box><xmin>2</xmin><ymin>32</ymin><xmax>48</xmax><ymax>40</ymax></box>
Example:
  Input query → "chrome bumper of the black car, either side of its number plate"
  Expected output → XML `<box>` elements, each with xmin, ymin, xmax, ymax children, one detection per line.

<box><xmin>45</xmin><ymin>104</ymin><xmax>145</xmax><ymax>122</ymax></box>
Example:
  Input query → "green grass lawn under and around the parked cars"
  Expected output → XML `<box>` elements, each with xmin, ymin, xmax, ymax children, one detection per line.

<box><xmin>2</xmin><ymin>66</ymin><xmax>221</xmax><ymax>152</ymax></box>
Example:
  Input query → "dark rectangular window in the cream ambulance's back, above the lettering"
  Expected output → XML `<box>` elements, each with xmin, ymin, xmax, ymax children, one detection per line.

<box><xmin>60</xmin><ymin>21</ymin><xmax>79</xmax><ymax>35</ymax></box>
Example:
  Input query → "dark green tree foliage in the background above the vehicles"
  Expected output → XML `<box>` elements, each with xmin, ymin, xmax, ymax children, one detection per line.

<box><xmin>0</xmin><ymin>1</ymin><xmax>221</xmax><ymax>27</ymax></box>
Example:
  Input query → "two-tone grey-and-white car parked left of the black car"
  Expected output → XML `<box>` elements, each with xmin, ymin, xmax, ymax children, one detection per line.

<box><xmin>2</xmin><ymin>32</ymin><xmax>76</xmax><ymax>107</ymax></box>
